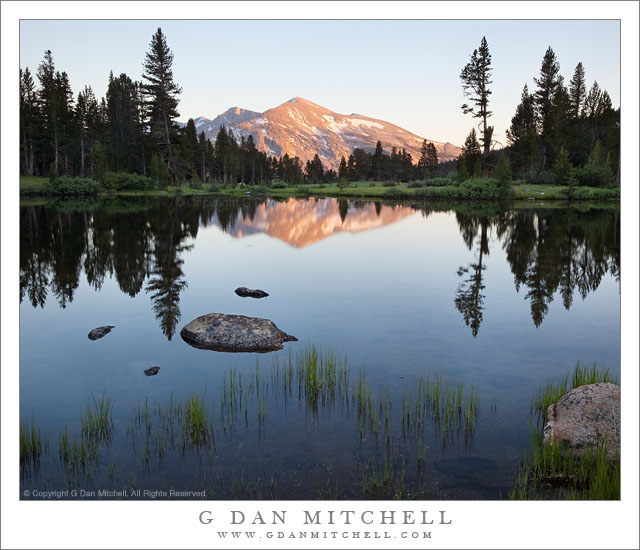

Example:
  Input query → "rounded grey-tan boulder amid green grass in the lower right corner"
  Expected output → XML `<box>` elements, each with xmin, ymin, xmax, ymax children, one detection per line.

<box><xmin>544</xmin><ymin>383</ymin><xmax>620</xmax><ymax>459</ymax></box>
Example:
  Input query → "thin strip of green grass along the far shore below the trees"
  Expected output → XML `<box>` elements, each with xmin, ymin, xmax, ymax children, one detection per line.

<box><xmin>20</xmin><ymin>176</ymin><xmax>620</xmax><ymax>202</ymax></box>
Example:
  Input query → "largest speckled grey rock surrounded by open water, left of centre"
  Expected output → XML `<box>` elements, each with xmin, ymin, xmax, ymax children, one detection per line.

<box><xmin>180</xmin><ymin>313</ymin><xmax>298</xmax><ymax>353</ymax></box>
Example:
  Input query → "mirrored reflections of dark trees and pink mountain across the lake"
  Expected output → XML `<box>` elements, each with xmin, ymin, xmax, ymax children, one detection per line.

<box><xmin>20</xmin><ymin>197</ymin><xmax>620</xmax><ymax>339</ymax></box>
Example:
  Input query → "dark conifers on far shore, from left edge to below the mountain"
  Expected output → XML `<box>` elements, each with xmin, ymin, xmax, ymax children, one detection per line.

<box><xmin>20</xmin><ymin>28</ymin><xmax>437</xmax><ymax>185</ymax></box>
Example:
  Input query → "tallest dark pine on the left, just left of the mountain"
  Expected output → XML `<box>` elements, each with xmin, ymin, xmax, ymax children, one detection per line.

<box><xmin>142</xmin><ymin>27</ymin><xmax>182</xmax><ymax>185</ymax></box>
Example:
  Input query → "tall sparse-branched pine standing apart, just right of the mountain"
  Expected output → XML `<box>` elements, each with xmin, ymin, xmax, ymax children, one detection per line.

<box><xmin>460</xmin><ymin>36</ymin><xmax>493</xmax><ymax>178</ymax></box>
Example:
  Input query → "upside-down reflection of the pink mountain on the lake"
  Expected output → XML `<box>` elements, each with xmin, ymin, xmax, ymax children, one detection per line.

<box><xmin>222</xmin><ymin>199</ymin><xmax>416</xmax><ymax>248</ymax></box>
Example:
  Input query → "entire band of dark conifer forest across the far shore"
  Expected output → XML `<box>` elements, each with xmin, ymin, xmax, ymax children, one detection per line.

<box><xmin>20</xmin><ymin>28</ymin><xmax>620</xmax><ymax>191</ymax></box>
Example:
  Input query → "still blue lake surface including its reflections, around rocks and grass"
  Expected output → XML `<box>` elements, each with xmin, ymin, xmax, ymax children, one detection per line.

<box><xmin>20</xmin><ymin>198</ymin><xmax>620</xmax><ymax>499</ymax></box>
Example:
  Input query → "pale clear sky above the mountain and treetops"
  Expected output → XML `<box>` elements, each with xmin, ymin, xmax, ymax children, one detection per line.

<box><xmin>20</xmin><ymin>20</ymin><xmax>620</xmax><ymax>145</ymax></box>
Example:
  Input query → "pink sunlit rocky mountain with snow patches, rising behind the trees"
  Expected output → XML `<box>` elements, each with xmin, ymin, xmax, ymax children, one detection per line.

<box><xmin>182</xmin><ymin>97</ymin><xmax>462</xmax><ymax>170</ymax></box>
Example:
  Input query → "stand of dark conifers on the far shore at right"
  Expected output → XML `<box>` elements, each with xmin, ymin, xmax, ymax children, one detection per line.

<box><xmin>457</xmin><ymin>37</ymin><xmax>620</xmax><ymax>187</ymax></box>
